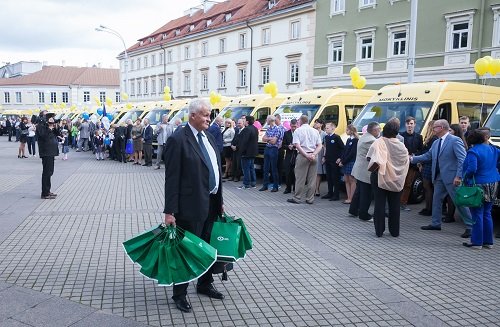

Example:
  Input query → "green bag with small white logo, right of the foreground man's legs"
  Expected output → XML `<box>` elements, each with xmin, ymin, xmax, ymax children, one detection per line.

<box><xmin>210</xmin><ymin>221</ymin><xmax>244</xmax><ymax>262</ymax></box>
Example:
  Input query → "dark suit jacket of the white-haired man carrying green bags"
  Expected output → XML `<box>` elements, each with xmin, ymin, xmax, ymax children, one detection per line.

<box><xmin>163</xmin><ymin>126</ymin><xmax>222</xmax><ymax>229</ymax></box>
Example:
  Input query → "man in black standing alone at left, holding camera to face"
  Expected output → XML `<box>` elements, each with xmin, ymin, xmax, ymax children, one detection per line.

<box><xmin>36</xmin><ymin>112</ymin><xmax>59</xmax><ymax>199</ymax></box>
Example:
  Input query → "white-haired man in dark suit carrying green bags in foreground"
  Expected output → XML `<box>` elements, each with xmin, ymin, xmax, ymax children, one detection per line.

<box><xmin>163</xmin><ymin>100</ymin><xmax>224</xmax><ymax>312</ymax></box>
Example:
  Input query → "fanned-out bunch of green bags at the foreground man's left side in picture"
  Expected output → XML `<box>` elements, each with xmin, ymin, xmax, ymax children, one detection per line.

<box><xmin>123</xmin><ymin>225</ymin><xmax>217</xmax><ymax>286</ymax></box>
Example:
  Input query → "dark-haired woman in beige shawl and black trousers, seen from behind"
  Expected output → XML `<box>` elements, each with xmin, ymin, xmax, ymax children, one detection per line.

<box><xmin>366</xmin><ymin>119</ymin><xmax>410</xmax><ymax>237</ymax></box>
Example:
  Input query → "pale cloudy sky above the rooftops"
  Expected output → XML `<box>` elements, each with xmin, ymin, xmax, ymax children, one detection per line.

<box><xmin>0</xmin><ymin>0</ymin><xmax>201</xmax><ymax>68</ymax></box>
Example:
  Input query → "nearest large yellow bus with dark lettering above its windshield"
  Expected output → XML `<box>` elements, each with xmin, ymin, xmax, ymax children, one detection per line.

<box><xmin>353</xmin><ymin>82</ymin><xmax>500</xmax><ymax>135</ymax></box>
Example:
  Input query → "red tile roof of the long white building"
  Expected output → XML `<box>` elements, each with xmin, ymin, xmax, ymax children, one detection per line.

<box><xmin>122</xmin><ymin>0</ymin><xmax>314</xmax><ymax>54</ymax></box>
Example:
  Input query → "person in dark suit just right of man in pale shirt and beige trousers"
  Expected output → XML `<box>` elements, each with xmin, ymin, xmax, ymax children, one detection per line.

<box><xmin>321</xmin><ymin>123</ymin><xmax>344</xmax><ymax>201</ymax></box>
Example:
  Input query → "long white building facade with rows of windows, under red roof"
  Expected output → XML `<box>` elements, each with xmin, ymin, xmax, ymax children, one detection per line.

<box><xmin>119</xmin><ymin>0</ymin><xmax>316</xmax><ymax>101</ymax></box>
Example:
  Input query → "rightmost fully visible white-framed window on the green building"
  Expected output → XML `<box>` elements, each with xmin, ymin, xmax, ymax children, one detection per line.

<box><xmin>445</xmin><ymin>10</ymin><xmax>475</xmax><ymax>51</ymax></box>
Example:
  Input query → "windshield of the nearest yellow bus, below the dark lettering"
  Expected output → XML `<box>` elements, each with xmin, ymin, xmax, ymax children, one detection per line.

<box><xmin>353</xmin><ymin>101</ymin><xmax>433</xmax><ymax>133</ymax></box>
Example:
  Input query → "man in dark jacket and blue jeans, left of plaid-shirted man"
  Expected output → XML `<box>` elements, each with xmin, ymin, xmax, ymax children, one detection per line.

<box><xmin>238</xmin><ymin>116</ymin><xmax>259</xmax><ymax>189</ymax></box>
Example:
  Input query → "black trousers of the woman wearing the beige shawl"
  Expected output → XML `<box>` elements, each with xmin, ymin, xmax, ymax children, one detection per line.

<box><xmin>370</xmin><ymin>172</ymin><xmax>401</xmax><ymax>237</ymax></box>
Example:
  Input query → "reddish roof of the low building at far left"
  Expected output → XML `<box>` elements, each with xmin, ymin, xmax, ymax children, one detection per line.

<box><xmin>0</xmin><ymin>66</ymin><xmax>120</xmax><ymax>87</ymax></box>
